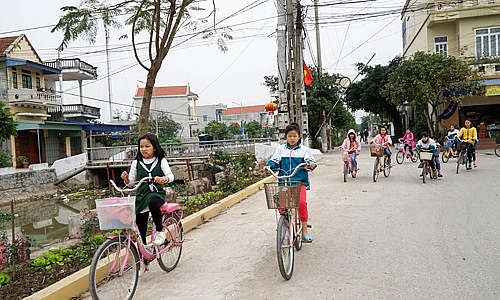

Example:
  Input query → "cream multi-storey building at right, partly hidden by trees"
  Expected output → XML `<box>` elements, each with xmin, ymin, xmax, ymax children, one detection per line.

<box><xmin>401</xmin><ymin>0</ymin><xmax>500</xmax><ymax>146</ymax></box>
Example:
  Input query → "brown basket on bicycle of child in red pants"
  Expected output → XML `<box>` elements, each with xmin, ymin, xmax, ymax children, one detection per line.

<box><xmin>264</xmin><ymin>181</ymin><xmax>302</xmax><ymax>209</ymax></box>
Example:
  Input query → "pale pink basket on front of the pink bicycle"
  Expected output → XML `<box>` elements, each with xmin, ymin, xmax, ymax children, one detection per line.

<box><xmin>95</xmin><ymin>197</ymin><xmax>135</xmax><ymax>230</ymax></box>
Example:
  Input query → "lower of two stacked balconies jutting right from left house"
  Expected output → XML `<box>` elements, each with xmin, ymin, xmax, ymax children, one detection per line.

<box><xmin>47</xmin><ymin>104</ymin><xmax>101</xmax><ymax>122</ymax></box>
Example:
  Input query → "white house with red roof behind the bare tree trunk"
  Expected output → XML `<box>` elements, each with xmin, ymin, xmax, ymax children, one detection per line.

<box><xmin>134</xmin><ymin>84</ymin><xmax>200</xmax><ymax>138</ymax></box>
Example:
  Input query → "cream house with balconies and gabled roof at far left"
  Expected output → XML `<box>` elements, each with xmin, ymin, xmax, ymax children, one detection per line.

<box><xmin>0</xmin><ymin>34</ymin><xmax>100</xmax><ymax>164</ymax></box>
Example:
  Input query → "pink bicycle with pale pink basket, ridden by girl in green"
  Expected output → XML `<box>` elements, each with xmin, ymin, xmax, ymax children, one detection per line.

<box><xmin>89</xmin><ymin>177</ymin><xmax>183</xmax><ymax>299</ymax></box>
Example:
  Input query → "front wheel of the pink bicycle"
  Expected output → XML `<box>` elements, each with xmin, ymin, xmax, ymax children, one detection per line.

<box><xmin>89</xmin><ymin>236</ymin><xmax>141</xmax><ymax>300</ymax></box>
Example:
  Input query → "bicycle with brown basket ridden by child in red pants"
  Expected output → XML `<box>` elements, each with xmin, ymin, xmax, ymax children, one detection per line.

<box><xmin>264</xmin><ymin>163</ymin><xmax>306</xmax><ymax>280</ymax></box>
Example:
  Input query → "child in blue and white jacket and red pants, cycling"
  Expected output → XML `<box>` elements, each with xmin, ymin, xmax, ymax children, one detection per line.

<box><xmin>266</xmin><ymin>123</ymin><xmax>316</xmax><ymax>243</ymax></box>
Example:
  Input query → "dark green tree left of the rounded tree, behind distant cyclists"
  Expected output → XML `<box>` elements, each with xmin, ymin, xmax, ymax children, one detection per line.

<box><xmin>345</xmin><ymin>56</ymin><xmax>403</xmax><ymax>136</ymax></box>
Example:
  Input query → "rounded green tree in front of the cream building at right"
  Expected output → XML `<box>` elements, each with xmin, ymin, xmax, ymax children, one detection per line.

<box><xmin>384</xmin><ymin>52</ymin><xmax>481</xmax><ymax>136</ymax></box>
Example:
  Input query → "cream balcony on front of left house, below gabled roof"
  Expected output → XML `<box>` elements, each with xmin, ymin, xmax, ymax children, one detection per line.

<box><xmin>7</xmin><ymin>89</ymin><xmax>61</xmax><ymax>107</ymax></box>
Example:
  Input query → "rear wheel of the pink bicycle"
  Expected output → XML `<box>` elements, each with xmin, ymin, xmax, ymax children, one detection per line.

<box><xmin>158</xmin><ymin>213</ymin><xmax>183</xmax><ymax>272</ymax></box>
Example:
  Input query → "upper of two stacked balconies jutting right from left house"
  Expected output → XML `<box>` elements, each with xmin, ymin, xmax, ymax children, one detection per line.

<box><xmin>44</xmin><ymin>58</ymin><xmax>97</xmax><ymax>80</ymax></box>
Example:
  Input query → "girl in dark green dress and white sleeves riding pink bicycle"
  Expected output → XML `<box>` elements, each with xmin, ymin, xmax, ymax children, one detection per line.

<box><xmin>121</xmin><ymin>133</ymin><xmax>174</xmax><ymax>245</ymax></box>
